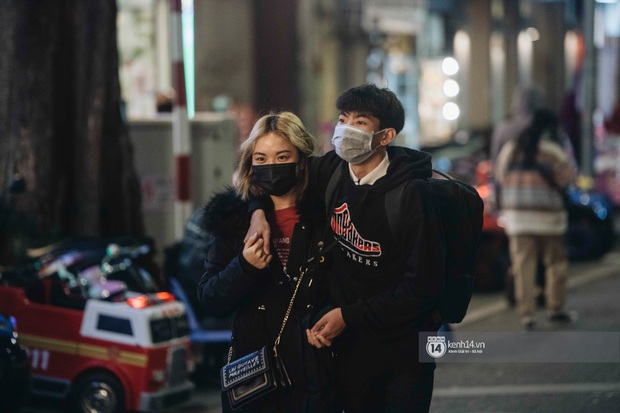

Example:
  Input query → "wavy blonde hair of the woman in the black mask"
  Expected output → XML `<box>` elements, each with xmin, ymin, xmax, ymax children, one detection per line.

<box><xmin>234</xmin><ymin>112</ymin><xmax>319</xmax><ymax>201</ymax></box>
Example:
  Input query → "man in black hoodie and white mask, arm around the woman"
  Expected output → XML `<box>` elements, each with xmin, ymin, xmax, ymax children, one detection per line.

<box><xmin>249</xmin><ymin>85</ymin><xmax>444</xmax><ymax>413</ymax></box>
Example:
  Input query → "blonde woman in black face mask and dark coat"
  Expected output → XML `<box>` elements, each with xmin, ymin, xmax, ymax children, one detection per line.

<box><xmin>198</xmin><ymin>112</ymin><xmax>334</xmax><ymax>412</ymax></box>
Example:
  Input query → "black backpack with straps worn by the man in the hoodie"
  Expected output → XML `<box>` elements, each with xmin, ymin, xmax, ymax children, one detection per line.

<box><xmin>325</xmin><ymin>166</ymin><xmax>484</xmax><ymax>323</ymax></box>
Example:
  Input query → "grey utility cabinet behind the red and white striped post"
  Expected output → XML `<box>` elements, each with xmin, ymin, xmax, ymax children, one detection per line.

<box><xmin>129</xmin><ymin>113</ymin><xmax>238</xmax><ymax>259</ymax></box>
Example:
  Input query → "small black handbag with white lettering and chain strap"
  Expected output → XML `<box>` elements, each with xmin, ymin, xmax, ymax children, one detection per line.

<box><xmin>221</xmin><ymin>270</ymin><xmax>305</xmax><ymax>410</ymax></box>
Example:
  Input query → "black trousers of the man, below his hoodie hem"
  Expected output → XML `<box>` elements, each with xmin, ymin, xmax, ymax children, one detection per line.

<box><xmin>336</xmin><ymin>346</ymin><xmax>435</xmax><ymax>413</ymax></box>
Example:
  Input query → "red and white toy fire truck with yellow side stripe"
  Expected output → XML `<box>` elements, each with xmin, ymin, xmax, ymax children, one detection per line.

<box><xmin>0</xmin><ymin>277</ymin><xmax>194</xmax><ymax>413</ymax></box>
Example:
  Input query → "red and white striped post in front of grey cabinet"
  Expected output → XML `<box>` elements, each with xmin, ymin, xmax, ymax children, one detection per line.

<box><xmin>170</xmin><ymin>0</ymin><xmax>193</xmax><ymax>239</ymax></box>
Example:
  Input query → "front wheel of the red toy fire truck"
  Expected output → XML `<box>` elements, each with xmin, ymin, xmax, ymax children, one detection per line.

<box><xmin>71</xmin><ymin>373</ymin><xmax>125</xmax><ymax>413</ymax></box>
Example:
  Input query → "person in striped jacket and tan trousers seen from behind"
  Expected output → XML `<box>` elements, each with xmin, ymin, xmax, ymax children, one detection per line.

<box><xmin>495</xmin><ymin>109</ymin><xmax>575</xmax><ymax>330</ymax></box>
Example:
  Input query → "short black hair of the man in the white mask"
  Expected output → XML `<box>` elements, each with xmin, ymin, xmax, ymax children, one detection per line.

<box><xmin>336</xmin><ymin>84</ymin><xmax>405</xmax><ymax>133</ymax></box>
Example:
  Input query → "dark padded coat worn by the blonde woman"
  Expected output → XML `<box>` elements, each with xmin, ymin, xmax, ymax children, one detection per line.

<box><xmin>198</xmin><ymin>189</ymin><xmax>333</xmax><ymax>413</ymax></box>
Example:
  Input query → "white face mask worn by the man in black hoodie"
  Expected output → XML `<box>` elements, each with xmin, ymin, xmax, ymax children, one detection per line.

<box><xmin>332</xmin><ymin>123</ymin><xmax>385</xmax><ymax>165</ymax></box>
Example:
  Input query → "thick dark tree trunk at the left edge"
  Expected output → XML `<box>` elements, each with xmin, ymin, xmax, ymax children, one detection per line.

<box><xmin>0</xmin><ymin>0</ymin><xmax>144</xmax><ymax>264</ymax></box>
